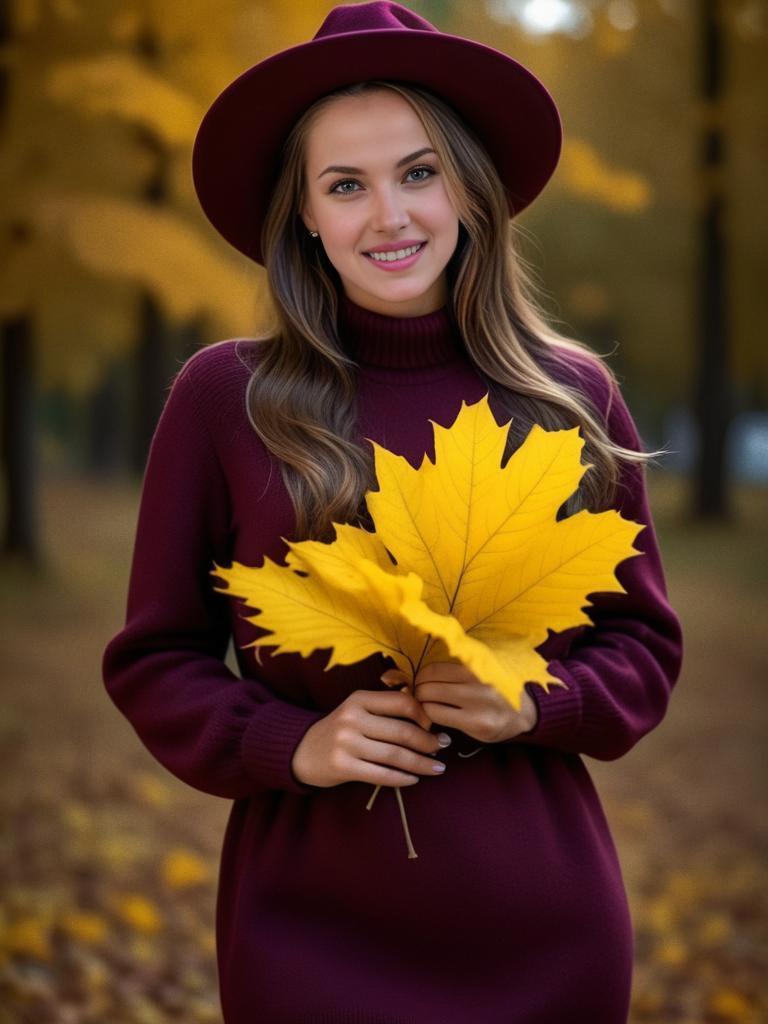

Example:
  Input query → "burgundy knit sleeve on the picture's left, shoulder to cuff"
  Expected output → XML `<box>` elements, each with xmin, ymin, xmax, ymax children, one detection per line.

<box><xmin>102</xmin><ymin>358</ymin><xmax>323</xmax><ymax>800</ymax></box>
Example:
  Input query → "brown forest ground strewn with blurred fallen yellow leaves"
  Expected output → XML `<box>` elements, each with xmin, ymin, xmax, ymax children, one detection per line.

<box><xmin>0</xmin><ymin>471</ymin><xmax>768</xmax><ymax>1024</ymax></box>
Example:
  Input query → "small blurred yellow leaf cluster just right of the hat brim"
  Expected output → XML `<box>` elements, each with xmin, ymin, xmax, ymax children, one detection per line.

<box><xmin>559</xmin><ymin>138</ymin><xmax>653</xmax><ymax>213</ymax></box>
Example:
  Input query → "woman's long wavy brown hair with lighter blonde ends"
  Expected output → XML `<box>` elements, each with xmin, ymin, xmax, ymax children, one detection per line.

<box><xmin>237</xmin><ymin>80</ymin><xmax>663</xmax><ymax>541</ymax></box>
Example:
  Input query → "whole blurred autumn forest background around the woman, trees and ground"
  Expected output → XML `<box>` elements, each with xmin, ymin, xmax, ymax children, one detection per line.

<box><xmin>0</xmin><ymin>0</ymin><xmax>768</xmax><ymax>1024</ymax></box>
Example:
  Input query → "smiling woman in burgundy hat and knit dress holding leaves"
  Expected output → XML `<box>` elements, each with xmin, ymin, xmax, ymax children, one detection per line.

<box><xmin>103</xmin><ymin>2</ymin><xmax>682</xmax><ymax>1024</ymax></box>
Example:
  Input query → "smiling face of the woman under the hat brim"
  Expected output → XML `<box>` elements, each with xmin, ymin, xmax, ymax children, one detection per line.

<box><xmin>301</xmin><ymin>91</ymin><xmax>459</xmax><ymax>316</ymax></box>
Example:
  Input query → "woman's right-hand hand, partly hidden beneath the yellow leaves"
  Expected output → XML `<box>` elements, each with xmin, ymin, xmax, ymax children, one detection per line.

<box><xmin>381</xmin><ymin>662</ymin><xmax>539</xmax><ymax>743</ymax></box>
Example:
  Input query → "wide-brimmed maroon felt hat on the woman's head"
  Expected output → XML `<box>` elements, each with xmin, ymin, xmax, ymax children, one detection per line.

<box><xmin>193</xmin><ymin>0</ymin><xmax>562</xmax><ymax>263</ymax></box>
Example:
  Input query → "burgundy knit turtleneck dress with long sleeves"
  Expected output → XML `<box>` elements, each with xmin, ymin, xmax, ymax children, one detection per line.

<box><xmin>102</xmin><ymin>297</ymin><xmax>682</xmax><ymax>1024</ymax></box>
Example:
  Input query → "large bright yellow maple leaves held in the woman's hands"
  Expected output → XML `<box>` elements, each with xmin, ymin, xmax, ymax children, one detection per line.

<box><xmin>212</xmin><ymin>395</ymin><xmax>642</xmax><ymax>710</ymax></box>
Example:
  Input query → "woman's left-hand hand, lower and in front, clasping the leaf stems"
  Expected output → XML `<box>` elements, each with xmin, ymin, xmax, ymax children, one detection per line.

<box><xmin>291</xmin><ymin>690</ymin><xmax>450</xmax><ymax>786</ymax></box>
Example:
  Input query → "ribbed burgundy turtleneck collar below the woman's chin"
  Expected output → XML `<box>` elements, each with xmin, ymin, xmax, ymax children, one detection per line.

<box><xmin>339</xmin><ymin>293</ymin><xmax>465</xmax><ymax>370</ymax></box>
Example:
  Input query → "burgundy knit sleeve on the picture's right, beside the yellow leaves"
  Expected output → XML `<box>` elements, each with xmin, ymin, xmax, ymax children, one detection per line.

<box><xmin>512</xmin><ymin>374</ymin><xmax>683</xmax><ymax>761</ymax></box>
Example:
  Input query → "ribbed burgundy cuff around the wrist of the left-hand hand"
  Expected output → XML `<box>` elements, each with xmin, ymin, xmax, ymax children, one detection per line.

<box><xmin>242</xmin><ymin>700</ymin><xmax>325</xmax><ymax>794</ymax></box>
